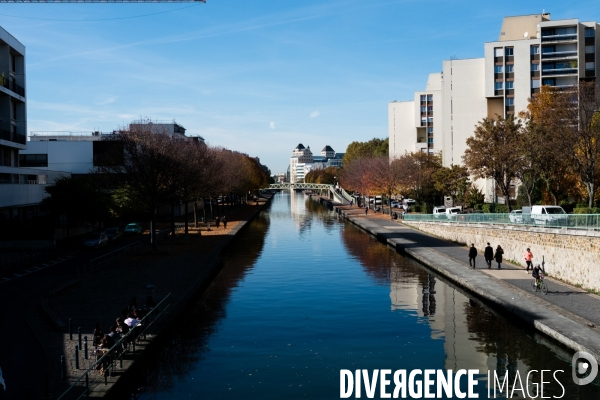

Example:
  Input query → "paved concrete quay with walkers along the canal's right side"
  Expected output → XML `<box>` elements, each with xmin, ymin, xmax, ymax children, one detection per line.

<box><xmin>335</xmin><ymin>206</ymin><xmax>600</xmax><ymax>361</ymax></box>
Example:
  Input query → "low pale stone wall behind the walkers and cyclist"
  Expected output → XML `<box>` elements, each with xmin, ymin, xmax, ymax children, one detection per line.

<box><xmin>404</xmin><ymin>221</ymin><xmax>600</xmax><ymax>291</ymax></box>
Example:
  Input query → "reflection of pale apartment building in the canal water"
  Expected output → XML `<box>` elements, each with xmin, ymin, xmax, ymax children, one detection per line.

<box><xmin>390</xmin><ymin>266</ymin><xmax>528</xmax><ymax>384</ymax></box>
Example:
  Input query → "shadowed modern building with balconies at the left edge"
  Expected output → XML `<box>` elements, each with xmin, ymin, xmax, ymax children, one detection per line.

<box><xmin>0</xmin><ymin>27</ymin><xmax>69</xmax><ymax>219</ymax></box>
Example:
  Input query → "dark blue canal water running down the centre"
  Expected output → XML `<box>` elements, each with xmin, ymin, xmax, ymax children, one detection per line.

<box><xmin>136</xmin><ymin>192</ymin><xmax>600</xmax><ymax>400</ymax></box>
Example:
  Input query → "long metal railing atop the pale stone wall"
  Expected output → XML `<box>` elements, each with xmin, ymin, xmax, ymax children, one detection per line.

<box><xmin>404</xmin><ymin>213</ymin><xmax>600</xmax><ymax>231</ymax></box>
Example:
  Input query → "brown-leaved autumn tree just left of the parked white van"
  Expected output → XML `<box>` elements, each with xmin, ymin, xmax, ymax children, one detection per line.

<box><xmin>463</xmin><ymin>115</ymin><xmax>522</xmax><ymax>212</ymax></box>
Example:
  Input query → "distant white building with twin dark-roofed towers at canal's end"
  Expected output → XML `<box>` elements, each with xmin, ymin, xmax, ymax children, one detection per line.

<box><xmin>289</xmin><ymin>143</ymin><xmax>345</xmax><ymax>183</ymax></box>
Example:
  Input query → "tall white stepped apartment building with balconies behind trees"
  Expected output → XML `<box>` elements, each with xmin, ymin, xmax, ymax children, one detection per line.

<box><xmin>388</xmin><ymin>13</ymin><xmax>600</xmax><ymax>199</ymax></box>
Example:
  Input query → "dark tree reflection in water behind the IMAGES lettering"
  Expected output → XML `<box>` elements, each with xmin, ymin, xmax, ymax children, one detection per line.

<box><xmin>464</xmin><ymin>300</ymin><xmax>600</xmax><ymax>400</ymax></box>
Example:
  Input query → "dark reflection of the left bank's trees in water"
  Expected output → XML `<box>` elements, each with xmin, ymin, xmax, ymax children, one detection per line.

<box><xmin>134</xmin><ymin>213</ymin><xmax>269</xmax><ymax>399</ymax></box>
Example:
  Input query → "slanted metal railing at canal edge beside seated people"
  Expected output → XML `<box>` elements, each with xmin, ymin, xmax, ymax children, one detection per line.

<box><xmin>57</xmin><ymin>293</ymin><xmax>171</xmax><ymax>400</ymax></box>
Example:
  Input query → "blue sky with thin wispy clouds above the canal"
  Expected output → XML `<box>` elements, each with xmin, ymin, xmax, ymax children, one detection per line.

<box><xmin>0</xmin><ymin>0</ymin><xmax>600</xmax><ymax>173</ymax></box>
